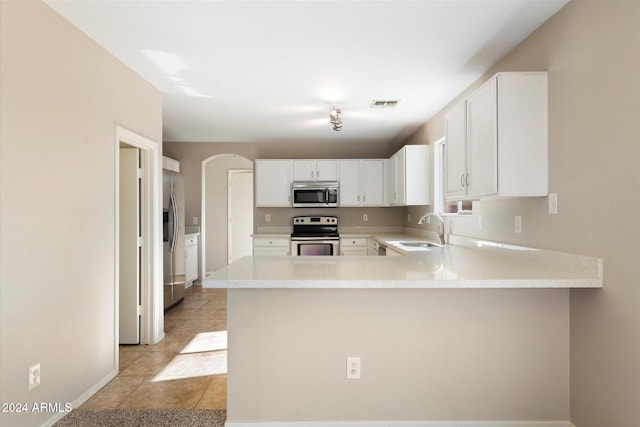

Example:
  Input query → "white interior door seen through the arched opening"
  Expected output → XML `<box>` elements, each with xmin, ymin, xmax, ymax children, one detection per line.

<box><xmin>228</xmin><ymin>170</ymin><xmax>253</xmax><ymax>264</ymax></box>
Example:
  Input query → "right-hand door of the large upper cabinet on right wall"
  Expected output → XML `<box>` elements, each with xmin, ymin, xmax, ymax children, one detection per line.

<box><xmin>467</xmin><ymin>78</ymin><xmax>498</xmax><ymax>197</ymax></box>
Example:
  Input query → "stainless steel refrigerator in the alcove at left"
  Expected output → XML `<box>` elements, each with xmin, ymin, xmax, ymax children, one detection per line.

<box><xmin>162</xmin><ymin>169</ymin><xmax>185</xmax><ymax>310</ymax></box>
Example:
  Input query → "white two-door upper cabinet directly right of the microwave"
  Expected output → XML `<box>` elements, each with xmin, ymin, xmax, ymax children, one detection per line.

<box><xmin>338</xmin><ymin>159</ymin><xmax>384</xmax><ymax>206</ymax></box>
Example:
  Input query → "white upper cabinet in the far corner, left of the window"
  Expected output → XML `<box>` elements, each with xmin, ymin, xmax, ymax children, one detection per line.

<box><xmin>388</xmin><ymin>145</ymin><xmax>431</xmax><ymax>206</ymax></box>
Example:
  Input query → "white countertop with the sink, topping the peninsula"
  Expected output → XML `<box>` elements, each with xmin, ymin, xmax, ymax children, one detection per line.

<box><xmin>203</xmin><ymin>233</ymin><xmax>603</xmax><ymax>289</ymax></box>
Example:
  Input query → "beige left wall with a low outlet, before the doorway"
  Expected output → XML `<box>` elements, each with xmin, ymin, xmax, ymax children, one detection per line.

<box><xmin>0</xmin><ymin>1</ymin><xmax>162</xmax><ymax>426</ymax></box>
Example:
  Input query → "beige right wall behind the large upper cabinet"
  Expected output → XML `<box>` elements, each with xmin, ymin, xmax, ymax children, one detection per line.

<box><xmin>416</xmin><ymin>0</ymin><xmax>640</xmax><ymax>427</ymax></box>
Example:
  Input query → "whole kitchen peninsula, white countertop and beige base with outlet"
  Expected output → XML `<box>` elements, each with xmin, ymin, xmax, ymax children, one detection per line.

<box><xmin>208</xmin><ymin>239</ymin><xmax>603</xmax><ymax>427</ymax></box>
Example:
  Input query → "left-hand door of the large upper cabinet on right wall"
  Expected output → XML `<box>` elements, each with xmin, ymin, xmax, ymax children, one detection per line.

<box><xmin>444</xmin><ymin>101</ymin><xmax>467</xmax><ymax>199</ymax></box>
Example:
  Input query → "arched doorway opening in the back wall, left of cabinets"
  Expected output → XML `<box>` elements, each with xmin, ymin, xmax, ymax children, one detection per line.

<box><xmin>200</xmin><ymin>154</ymin><xmax>253</xmax><ymax>278</ymax></box>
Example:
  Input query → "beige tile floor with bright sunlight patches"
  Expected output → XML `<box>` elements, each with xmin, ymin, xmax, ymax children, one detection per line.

<box><xmin>82</xmin><ymin>285</ymin><xmax>227</xmax><ymax>409</ymax></box>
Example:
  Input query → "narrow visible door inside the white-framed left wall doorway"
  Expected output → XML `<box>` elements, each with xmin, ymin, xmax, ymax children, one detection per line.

<box><xmin>119</xmin><ymin>148</ymin><xmax>140</xmax><ymax>344</ymax></box>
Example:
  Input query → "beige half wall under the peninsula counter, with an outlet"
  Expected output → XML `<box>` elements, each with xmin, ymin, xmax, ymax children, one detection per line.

<box><xmin>227</xmin><ymin>288</ymin><xmax>569</xmax><ymax>425</ymax></box>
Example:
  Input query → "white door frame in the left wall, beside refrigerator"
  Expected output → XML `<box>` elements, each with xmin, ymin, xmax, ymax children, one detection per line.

<box><xmin>114</xmin><ymin>126</ymin><xmax>164</xmax><ymax>369</ymax></box>
